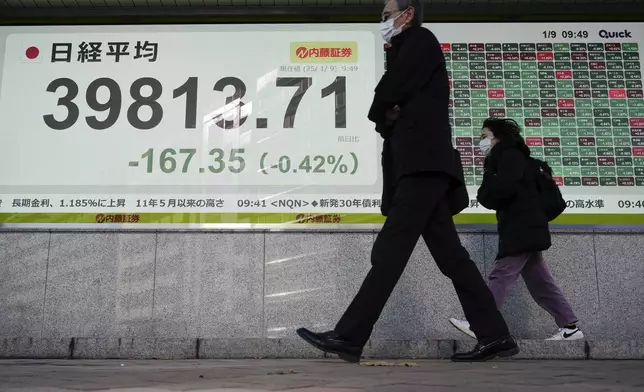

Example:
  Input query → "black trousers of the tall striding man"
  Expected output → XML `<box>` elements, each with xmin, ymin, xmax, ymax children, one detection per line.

<box><xmin>335</xmin><ymin>173</ymin><xmax>509</xmax><ymax>345</ymax></box>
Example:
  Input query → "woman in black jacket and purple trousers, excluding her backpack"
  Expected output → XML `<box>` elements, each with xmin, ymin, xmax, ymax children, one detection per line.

<box><xmin>450</xmin><ymin>119</ymin><xmax>584</xmax><ymax>340</ymax></box>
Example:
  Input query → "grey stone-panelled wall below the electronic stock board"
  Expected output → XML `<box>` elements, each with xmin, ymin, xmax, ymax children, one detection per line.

<box><xmin>0</xmin><ymin>231</ymin><xmax>644</xmax><ymax>358</ymax></box>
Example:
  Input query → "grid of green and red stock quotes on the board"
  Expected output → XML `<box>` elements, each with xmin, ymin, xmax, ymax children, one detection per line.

<box><xmin>441</xmin><ymin>42</ymin><xmax>644</xmax><ymax>187</ymax></box>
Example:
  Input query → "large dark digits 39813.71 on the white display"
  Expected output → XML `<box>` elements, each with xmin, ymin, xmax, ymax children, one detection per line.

<box><xmin>43</xmin><ymin>76</ymin><xmax>347</xmax><ymax>130</ymax></box>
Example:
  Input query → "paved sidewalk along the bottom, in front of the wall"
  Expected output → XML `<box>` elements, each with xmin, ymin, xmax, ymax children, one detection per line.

<box><xmin>0</xmin><ymin>360</ymin><xmax>644</xmax><ymax>392</ymax></box>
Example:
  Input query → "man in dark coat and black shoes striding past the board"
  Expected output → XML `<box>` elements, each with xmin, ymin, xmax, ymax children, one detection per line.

<box><xmin>297</xmin><ymin>0</ymin><xmax>518</xmax><ymax>362</ymax></box>
